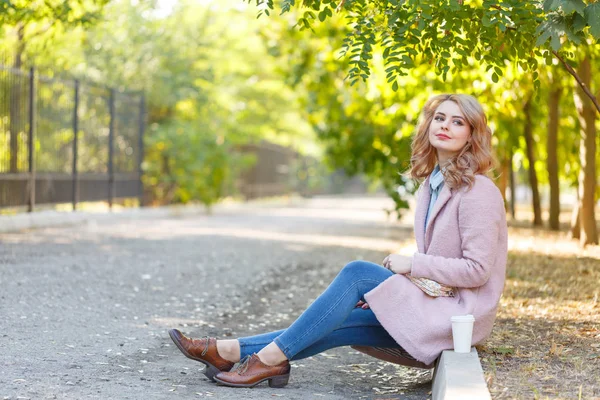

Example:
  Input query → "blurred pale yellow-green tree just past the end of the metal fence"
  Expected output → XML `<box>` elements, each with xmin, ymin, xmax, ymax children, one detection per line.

<box><xmin>82</xmin><ymin>0</ymin><xmax>313</xmax><ymax>206</ymax></box>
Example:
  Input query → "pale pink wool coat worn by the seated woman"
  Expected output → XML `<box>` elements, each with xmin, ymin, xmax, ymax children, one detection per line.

<box><xmin>365</xmin><ymin>175</ymin><xmax>507</xmax><ymax>364</ymax></box>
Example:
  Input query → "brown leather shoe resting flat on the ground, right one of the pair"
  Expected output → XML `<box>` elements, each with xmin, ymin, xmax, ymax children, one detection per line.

<box><xmin>214</xmin><ymin>354</ymin><xmax>290</xmax><ymax>387</ymax></box>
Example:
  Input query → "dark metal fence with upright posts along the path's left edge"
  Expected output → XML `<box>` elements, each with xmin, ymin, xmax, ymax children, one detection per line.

<box><xmin>0</xmin><ymin>65</ymin><xmax>145</xmax><ymax>211</ymax></box>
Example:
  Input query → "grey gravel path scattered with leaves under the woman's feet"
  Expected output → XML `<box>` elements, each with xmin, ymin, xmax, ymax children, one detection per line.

<box><xmin>0</xmin><ymin>198</ymin><xmax>431</xmax><ymax>400</ymax></box>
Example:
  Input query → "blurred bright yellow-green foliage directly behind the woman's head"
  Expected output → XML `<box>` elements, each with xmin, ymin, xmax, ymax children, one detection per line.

<box><xmin>264</xmin><ymin>10</ymin><xmax>522</xmax><ymax>213</ymax></box>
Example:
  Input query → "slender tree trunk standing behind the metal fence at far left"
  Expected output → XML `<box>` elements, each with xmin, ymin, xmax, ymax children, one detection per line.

<box><xmin>8</xmin><ymin>24</ymin><xmax>25</xmax><ymax>172</ymax></box>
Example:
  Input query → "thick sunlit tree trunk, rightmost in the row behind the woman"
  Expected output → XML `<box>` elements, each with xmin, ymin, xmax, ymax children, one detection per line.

<box><xmin>575</xmin><ymin>55</ymin><xmax>598</xmax><ymax>246</ymax></box>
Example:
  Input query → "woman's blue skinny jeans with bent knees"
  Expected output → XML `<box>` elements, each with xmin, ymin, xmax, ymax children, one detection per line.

<box><xmin>238</xmin><ymin>261</ymin><xmax>400</xmax><ymax>360</ymax></box>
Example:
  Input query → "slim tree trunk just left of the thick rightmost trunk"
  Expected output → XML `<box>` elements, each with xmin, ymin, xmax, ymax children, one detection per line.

<box><xmin>546</xmin><ymin>86</ymin><xmax>561</xmax><ymax>231</ymax></box>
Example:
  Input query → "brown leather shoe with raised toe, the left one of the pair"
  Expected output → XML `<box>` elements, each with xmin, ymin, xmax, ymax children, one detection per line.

<box><xmin>169</xmin><ymin>329</ymin><xmax>235</xmax><ymax>382</ymax></box>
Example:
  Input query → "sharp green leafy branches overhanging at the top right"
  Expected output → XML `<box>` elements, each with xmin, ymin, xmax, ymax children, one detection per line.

<box><xmin>249</xmin><ymin>0</ymin><xmax>600</xmax><ymax>243</ymax></box>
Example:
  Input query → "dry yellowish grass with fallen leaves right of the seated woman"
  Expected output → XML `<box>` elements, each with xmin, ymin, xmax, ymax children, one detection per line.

<box><xmin>478</xmin><ymin>227</ymin><xmax>600</xmax><ymax>399</ymax></box>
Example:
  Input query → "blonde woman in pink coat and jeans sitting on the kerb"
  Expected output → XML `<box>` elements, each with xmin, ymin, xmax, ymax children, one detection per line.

<box><xmin>169</xmin><ymin>94</ymin><xmax>507</xmax><ymax>387</ymax></box>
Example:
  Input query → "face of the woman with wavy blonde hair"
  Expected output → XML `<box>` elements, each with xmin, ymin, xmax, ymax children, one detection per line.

<box><xmin>429</xmin><ymin>100</ymin><xmax>471</xmax><ymax>165</ymax></box>
